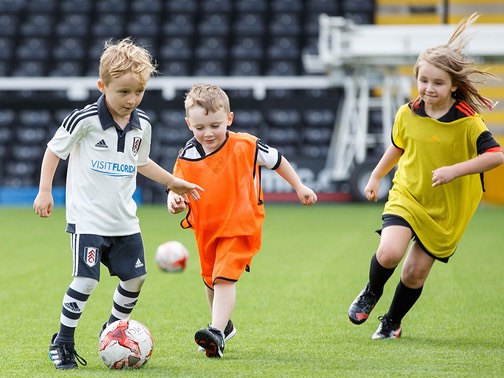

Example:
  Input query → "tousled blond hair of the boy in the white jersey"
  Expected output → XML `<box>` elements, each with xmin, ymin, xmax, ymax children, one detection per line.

<box><xmin>99</xmin><ymin>37</ymin><xmax>156</xmax><ymax>86</ymax></box>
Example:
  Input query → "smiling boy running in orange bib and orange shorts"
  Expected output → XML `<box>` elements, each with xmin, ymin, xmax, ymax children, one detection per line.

<box><xmin>168</xmin><ymin>84</ymin><xmax>317</xmax><ymax>357</ymax></box>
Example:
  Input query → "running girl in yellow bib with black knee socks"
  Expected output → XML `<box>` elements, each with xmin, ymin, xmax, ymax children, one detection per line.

<box><xmin>348</xmin><ymin>13</ymin><xmax>504</xmax><ymax>339</ymax></box>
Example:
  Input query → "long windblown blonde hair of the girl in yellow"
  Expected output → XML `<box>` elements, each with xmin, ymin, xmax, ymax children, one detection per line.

<box><xmin>412</xmin><ymin>12</ymin><xmax>497</xmax><ymax>112</ymax></box>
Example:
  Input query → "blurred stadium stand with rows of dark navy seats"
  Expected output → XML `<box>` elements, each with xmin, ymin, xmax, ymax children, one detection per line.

<box><xmin>0</xmin><ymin>0</ymin><xmax>504</xmax><ymax>202</ymax></box>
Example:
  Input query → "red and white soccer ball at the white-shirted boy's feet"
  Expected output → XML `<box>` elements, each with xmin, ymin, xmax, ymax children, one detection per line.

<box><xmin>99</xmin><ymin>319</ymin><xmax>154</xmax><ymax>370</ymax></box>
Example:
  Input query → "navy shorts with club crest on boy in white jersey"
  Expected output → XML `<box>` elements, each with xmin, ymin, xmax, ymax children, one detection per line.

<box><xmin>70</xmin><ymin>233</ymin><xmax>147</xmax><ymax>281</ymax></box>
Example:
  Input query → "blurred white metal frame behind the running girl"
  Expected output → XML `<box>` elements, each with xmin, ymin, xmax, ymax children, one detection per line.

<box><xmin>303</xmin><ymin>14</ymin><xmax>504</xmax><ymax>181</ymax></box>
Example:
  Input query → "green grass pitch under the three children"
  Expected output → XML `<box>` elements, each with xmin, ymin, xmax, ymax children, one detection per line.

<box><xmin>0</xmin><ymin>204</ymin><xmax>504</xmax><ymax>378</ymax></box>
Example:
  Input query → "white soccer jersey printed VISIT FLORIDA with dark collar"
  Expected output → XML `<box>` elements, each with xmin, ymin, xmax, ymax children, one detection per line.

<box><xmin>47</xmin><ymin>95</ymin><xmax>151</xmax><ymax>236</ymax></box>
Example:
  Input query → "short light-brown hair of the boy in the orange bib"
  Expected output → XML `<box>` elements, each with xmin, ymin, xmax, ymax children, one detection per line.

<box><xmin>184</xmin><ymin>84</ymin><xmax>231</xmax><ymax>117</ymax></box>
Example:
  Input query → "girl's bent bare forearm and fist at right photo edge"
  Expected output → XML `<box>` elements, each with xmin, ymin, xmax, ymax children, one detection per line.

<box><xmin>432</xmin><ymin>151</ymin><xmax>504</xmax><ymax>186</ymax></box>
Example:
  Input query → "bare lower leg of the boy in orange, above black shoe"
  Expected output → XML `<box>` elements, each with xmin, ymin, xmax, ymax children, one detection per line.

<box><xmin>212</xmin><ymin>280</ymin><xmax>236</xmax><ymax>332</ymax></box>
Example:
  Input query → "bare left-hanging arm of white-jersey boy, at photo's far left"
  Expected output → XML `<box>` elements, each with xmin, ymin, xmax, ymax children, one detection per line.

<box><xmin>33</xmin><ymin>148</ymin><xmax>60</xmax><ymax>218</ymax></box>
